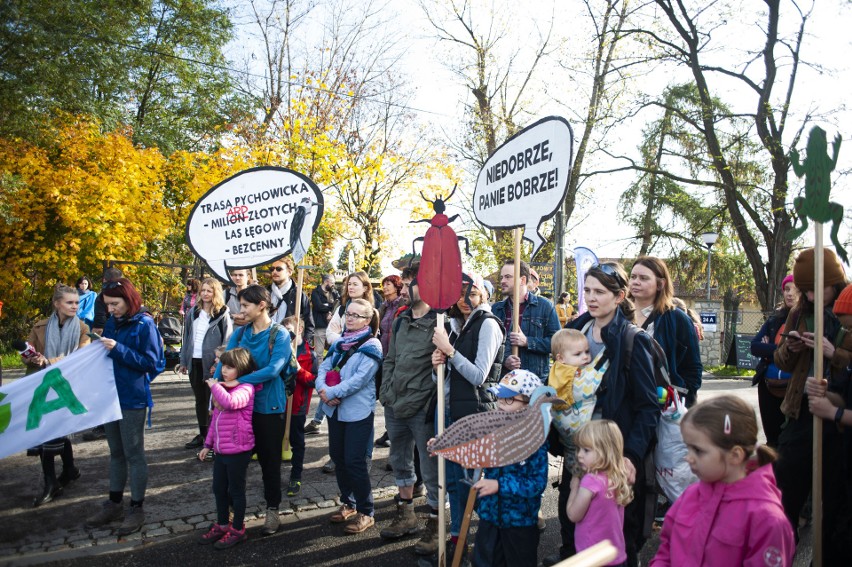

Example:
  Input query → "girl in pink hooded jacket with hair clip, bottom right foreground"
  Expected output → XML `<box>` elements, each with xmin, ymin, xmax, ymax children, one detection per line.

<box><xmin>651</xmin><ymin>396</ymin><xmax>796</xmax><ymax>567</ymax></box>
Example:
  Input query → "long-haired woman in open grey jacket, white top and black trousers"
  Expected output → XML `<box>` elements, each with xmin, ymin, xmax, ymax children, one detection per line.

<box><xmin>178</xmin><ymin>278</ymin><xmax>233</xmax><ymax>452</ymax></box>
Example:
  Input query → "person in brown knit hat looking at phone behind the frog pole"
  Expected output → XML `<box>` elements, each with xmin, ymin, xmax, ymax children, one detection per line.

<box><xmin>775</xmin><ymin>248</ymin><xmax>848</xmax><ymax>565</ymax></box>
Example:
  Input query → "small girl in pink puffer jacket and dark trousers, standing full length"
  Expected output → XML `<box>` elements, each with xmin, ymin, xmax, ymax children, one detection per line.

<box><xmin>198</xmin><ymin>348</ymin><xmax>257</xmax><ymax>549</ymax></box>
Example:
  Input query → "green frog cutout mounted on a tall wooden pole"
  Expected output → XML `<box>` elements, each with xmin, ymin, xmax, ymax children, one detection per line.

<box><xmin>787</xmin><ymin>126</ymin><xmax>848</xmax><ymax>567</ymax></box>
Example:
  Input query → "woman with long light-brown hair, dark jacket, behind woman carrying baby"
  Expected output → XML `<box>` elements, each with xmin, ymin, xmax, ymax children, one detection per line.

<box><xmin>627</xmin><ymin>256</ymin><xmax>704</xmax><ymax>407</ymax></box>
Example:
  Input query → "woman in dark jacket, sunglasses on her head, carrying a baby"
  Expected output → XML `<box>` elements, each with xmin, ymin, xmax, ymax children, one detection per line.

<box><xmin>545</xmin><ymin>263</ymin><xmax>660</xmax><ymax>565</ymax></box>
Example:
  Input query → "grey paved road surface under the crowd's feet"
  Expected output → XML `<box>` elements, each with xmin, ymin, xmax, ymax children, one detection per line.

<box><xmin>0</xmin><ymin>375</ymin><xmax>810</xmax><ymax>567</ymax></box>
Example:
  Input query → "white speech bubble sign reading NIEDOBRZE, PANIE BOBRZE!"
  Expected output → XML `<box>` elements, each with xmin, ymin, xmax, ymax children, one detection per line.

<box><xmin>473</xmin><ymin>116</ymin><xmax>574</xmax><ymax>257</ymax></box>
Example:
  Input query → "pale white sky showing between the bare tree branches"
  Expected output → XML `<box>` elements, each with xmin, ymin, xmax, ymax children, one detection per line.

<box><xmin>226</xmin><ymin>0</ymin><xmax>852</xmax><ymax>272</ymax></box>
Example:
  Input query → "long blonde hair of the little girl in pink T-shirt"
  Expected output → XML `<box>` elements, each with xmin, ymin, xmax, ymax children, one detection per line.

<box><xmin>574</xmin><ymin>419</ymin><xmax>633</xmax><ymax>506</ymax></box>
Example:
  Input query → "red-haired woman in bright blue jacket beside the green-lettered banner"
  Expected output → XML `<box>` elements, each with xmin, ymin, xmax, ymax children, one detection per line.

<box><xmin>86</xmin><ymin>278</ymin><xmax>165</xmax><ymax>536</ymax></box>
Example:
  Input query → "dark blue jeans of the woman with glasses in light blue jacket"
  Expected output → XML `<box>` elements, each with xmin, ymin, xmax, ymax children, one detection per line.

<box><xmin>328</xmin><ymin>412</ymin><xmax>375</xmax><ymax>516</ymax></box>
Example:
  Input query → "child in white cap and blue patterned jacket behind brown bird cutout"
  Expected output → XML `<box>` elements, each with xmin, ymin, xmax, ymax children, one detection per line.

<box><xmin>473</xmin><ymin>370</ymin><xmax>547</xmax><ymax>567</ymax></box>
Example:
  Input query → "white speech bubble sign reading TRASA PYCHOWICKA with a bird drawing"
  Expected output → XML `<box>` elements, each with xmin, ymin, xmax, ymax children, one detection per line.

<box><xmin>186</xmin><ymin>167</ymin><xmax>324</xmax><ymax>282</ymax></box>
